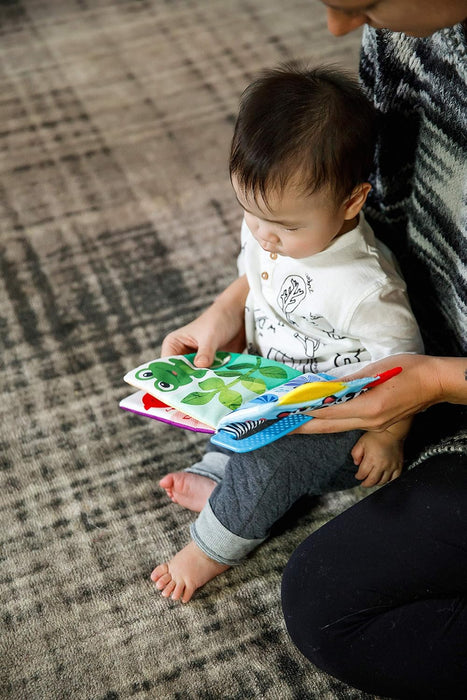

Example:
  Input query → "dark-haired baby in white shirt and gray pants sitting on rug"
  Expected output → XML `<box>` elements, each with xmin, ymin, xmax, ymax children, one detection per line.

<box><xmin>151</xmin><ymin>65</ymin><xmax>423</xmax><ymax>602</ymax></box>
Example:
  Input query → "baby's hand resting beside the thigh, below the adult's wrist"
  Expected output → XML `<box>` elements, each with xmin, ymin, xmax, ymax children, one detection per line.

<box><xmin>351</xmin><ymin>430</ymin><xmax>404</xmax><ymax>487</ymax></box>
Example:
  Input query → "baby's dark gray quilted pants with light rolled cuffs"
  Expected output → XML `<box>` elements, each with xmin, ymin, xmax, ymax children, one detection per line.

<box><xmin>186</xmin><ymin>430</ymin><xmax>362</xmax><ymax>566</ymax></box>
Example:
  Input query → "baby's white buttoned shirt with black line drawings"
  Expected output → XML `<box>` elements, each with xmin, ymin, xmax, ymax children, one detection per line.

<box><xmin>239</xmin><ymin>213</ymin><xmax>423</xmax><ymax>377</ymax></box>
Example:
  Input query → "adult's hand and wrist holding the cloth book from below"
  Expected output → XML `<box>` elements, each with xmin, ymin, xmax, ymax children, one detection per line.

<box><xmin>294</xmin><ymin>354</ymin><xmax>467</xmax><ymax>434</ymax></box>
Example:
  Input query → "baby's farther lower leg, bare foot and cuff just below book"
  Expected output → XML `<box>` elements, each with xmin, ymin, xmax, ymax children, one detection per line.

<box><xmin>159</xmin><ymin>443</ymin><xmax>231</xmax><ymax>513</ymax></box>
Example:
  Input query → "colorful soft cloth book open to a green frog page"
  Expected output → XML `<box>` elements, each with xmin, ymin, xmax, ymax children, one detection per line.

<box><xmin>120</xmin><ymin>352</ymin><xmax>401</xmax><ymax>452</ymax></box>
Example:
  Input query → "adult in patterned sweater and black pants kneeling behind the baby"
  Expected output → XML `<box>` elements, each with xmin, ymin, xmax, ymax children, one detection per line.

<box><xmin>282</xmin><ymin>0</ymin><xmax>467</xmax><ymax>700</ymax></box>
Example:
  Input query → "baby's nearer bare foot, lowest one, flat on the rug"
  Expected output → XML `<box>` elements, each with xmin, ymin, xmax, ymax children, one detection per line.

<box><xmin>151</xmin><ymin>542</ymin><xmax>230</xmax><ymax>603</ymax></box>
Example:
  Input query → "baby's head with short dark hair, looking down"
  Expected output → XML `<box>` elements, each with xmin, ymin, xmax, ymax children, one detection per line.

<box><xmin>230</xmin><ymin>65</ymin><xmax>375</xmax><ymax>258</ymax></box>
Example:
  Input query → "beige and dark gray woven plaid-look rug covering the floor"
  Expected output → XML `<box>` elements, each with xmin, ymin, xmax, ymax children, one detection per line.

<box><xmin>0</xmin><ymin>0</ymin><xmax>386</xmax><ymax>700</ymax></box>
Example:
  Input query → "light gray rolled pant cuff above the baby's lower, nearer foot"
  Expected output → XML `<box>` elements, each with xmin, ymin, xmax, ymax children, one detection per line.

<box><xmin>190</xmin><ymin>501</ymin><xmax>266</xmax><ymax>566</ymax></box>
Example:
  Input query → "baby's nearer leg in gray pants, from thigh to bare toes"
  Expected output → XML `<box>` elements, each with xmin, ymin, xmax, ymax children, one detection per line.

<box><xmin>151</xmin><ymin>432</ymin><xmax>361</xmax><ymax>602</ymax></box>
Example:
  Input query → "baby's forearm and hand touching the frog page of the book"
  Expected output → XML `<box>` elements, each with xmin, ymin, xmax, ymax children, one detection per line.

<box><xmin>161</xmin><ymin>276</ymin><xmax>248</xmax><ymax>367</ymax></box>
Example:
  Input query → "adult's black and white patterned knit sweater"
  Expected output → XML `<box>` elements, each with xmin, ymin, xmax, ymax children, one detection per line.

<box><xmin>360</xmin><ymin>24</ymin><xmax>467</xmax><ymax>462</ymax></box>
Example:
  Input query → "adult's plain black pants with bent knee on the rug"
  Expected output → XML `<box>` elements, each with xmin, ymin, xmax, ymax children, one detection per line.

<box><xmin>282</xmin><ymin>454</ymin><xmax>467</xmax><ymax>700</ymax></box>
